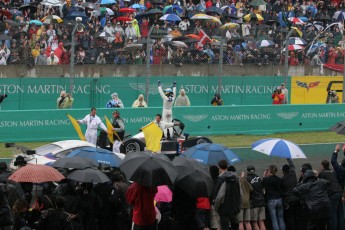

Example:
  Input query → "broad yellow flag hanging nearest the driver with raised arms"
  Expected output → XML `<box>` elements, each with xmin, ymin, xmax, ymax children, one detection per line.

<box><xmin>142</xmin><ymin>122</ymin><xmax>163</xmax><ymax>153</ymax></box>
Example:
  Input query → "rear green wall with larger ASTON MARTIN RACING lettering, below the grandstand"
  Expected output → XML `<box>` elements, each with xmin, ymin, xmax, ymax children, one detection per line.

<box><xmin>0</xmin><ymin>77</ymin><xmax>284</xmax><ymax>110</ymax></box>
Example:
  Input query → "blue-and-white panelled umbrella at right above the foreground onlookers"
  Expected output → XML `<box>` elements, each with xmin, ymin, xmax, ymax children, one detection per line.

<box><xmin>252</xmin><ymin>138</ymin><xmax>307</xmax><ymax>159</ymax></box>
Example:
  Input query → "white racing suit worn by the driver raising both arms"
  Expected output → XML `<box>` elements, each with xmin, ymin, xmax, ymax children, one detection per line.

<box><xmin>158</xmin><ymin>86</ymin><xmax>176</xmax><ymax>138</ymax></box>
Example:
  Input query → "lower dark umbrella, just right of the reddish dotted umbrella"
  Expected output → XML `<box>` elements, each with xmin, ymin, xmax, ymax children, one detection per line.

<box><xmin>67</xmin><ymin>168</ymin><xmax>110</xmax><ymax>183</ymax></box>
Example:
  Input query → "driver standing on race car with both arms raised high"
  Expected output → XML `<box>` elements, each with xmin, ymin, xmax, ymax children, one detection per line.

<box><xmin>158</xmin><ymin>81</ymin><xmax>176</xmax><ymax>139</ymax></box>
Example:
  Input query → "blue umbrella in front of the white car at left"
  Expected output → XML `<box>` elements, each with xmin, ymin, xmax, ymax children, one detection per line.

<box><xmin>67</xmin><ymin>147</ymin><xmax>122</xmax><ymax>167</ymax></box>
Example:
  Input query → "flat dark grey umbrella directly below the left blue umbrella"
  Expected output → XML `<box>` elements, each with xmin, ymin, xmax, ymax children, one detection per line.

<box><xmin>52</xmin><ymin>157</ymin><xmax>98</xmax><ymax>169</ymax></box>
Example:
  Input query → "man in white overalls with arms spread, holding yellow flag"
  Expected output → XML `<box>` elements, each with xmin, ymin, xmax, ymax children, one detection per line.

<box><xmin>77</xmin><ymin>108</ymin><xmax>108</xmax><ymax>145</ymax></box>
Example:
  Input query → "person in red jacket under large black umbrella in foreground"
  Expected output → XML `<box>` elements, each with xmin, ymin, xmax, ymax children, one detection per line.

<box><xmin>126</xmin><ymin>182</ymin><xmax>157</xmax><ymax>230</ymax></box>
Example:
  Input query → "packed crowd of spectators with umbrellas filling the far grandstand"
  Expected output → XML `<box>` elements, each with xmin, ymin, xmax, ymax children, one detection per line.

<box><xmin>0</xmin><ymin>0</ymin><xmax>345</xmax><ymax>69</ymax></box>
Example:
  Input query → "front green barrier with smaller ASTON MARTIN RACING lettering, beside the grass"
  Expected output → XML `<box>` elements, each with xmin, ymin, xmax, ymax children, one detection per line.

<box><xmin>0</xmin><ymin>104</ymin><xmax>345</xmax><ymax>142</ymax></box>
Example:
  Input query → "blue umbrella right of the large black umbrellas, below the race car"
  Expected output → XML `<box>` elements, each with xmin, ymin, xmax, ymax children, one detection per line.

<box><xmin>181</xmin><ymin>143</ymin><xmax>241</xmax><ymax>165</ymax></box>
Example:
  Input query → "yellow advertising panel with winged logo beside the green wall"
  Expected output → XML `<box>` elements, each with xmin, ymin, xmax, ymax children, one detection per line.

<box><xmin>290</xmin><ymin>76</ymin><xmax>343</xmax><ymax>104</ymax></box>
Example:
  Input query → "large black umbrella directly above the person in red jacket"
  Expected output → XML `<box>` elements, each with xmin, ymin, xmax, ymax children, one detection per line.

<box><xmin>120</xmin><ymin>152</ymin><xmax>177</xmax><ymax>187</ymax></box>
